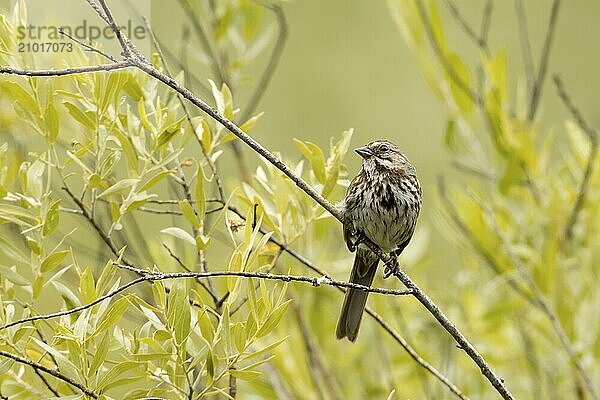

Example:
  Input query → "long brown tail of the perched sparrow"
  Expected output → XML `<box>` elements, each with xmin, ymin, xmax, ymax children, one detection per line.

<box><xmin>335</xmin><ymin>248</ymin><xmax>379</xmax><ymax>342</ymax></box>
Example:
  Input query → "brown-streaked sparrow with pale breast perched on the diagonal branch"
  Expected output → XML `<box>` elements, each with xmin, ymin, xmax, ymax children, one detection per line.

<box><xmin>336</xmin><ymin>140</ymin><xmax>422</xmax><ymax>341</ymax></box>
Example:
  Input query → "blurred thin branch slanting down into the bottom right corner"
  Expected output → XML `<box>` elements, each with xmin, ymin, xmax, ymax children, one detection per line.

<box><xmin>480</xmin><ymin>202</ymin><xmax>600</xmax><ymax>400</ymax></box>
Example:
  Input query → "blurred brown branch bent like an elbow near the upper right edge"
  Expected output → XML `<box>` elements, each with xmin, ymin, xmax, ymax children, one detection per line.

<box><xmin>554</xmin><ymin>75</ymin><xmax>598</xmax><ymax>240</ymax></box>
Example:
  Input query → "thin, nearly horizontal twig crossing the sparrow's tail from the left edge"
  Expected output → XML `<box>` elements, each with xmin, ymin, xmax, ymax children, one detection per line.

<box><xmin>0</xmin><ymin>270</ymin><xmax>412</xmax><ymax>331</ymax></box>
